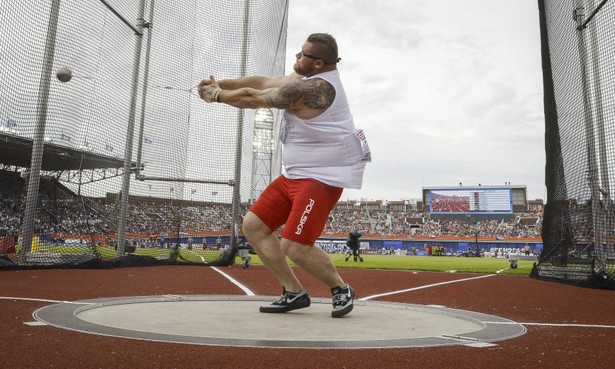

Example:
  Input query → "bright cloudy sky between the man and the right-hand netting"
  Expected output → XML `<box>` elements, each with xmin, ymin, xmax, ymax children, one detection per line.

<box><xmin>287</xmin><ymin>0</ymin><xmax>545</xmax><ymax>199</ymax></box>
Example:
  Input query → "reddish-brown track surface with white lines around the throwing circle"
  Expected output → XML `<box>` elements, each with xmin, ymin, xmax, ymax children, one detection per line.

<box><xmin>0</xmin><ymin>266</ymin><xmax>615</xmax><ymax>369</ymax></box>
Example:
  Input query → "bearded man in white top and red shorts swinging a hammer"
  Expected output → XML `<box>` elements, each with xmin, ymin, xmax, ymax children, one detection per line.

<box><xmin>199</xmin><ymin>33</ymin><xmax>371</xmax><ymax>318</ymax></box>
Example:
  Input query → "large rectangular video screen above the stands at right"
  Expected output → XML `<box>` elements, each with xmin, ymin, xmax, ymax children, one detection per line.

<box><xmin>429</xmin><ymin>187</ymin><xmax>513</xmax><ymax>214</ymax></box>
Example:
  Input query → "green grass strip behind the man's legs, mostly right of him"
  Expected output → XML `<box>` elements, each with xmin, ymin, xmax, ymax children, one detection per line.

<box><xmin>237</xmin><ymin>254</ymin><xmax>534</xmax><ymax>275</ymax></box>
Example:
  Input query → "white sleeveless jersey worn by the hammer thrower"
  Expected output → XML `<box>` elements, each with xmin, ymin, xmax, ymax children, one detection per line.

<box><xmin>280</xmin><ymin>70</ymin><xmax>371</xmax><ymax>189</ymax></box>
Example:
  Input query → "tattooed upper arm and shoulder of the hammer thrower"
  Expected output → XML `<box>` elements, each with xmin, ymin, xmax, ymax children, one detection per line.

<box><xmin>264</xmin><ymin>78</ymin><xmax>335</xmax><ymax>109</ymax></box>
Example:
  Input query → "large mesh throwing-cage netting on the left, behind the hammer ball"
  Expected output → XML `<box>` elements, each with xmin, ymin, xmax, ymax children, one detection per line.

<box><xmin>0</xmin><ymin>0</ymin><xmax>288</xmax><ymax>268</ymax></box>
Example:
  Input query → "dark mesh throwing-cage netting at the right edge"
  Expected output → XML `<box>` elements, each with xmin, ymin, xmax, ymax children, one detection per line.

<box><xmin>532</xmin><ymin>0</ymin><xmax>615</xmax><ymax>289</ymax></box>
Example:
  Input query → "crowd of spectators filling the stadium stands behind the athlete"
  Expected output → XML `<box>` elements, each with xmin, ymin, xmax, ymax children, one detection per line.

<box><xmin>0</xmin><ymin>198</ymin><xmax>542</xmax><ymax>238</ymax></box>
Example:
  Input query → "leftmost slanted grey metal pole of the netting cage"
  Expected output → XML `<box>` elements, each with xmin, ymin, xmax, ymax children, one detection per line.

<box><xmin>19</xmin><ymin>0</ymin><xmax>60</xmax><ymax>262</ymax></box>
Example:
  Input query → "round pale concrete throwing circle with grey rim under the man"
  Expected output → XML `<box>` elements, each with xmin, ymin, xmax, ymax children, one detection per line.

<box><xmin>34</xmin><ymin>295</ymin><xmax>525</xmax><ymax>348</ymax></box>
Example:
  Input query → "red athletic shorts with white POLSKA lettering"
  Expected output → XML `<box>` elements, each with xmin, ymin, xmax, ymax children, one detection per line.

<box><xmin>250</xmin><ymin>176</ymin><xmax>344</xmax><ymax>246</ymax></box>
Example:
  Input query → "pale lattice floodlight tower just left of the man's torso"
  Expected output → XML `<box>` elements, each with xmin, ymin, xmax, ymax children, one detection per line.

<box><xmin>250</xmin><ymin>109</ymin><xmax>275</xmax><ymax>202</ymax></box>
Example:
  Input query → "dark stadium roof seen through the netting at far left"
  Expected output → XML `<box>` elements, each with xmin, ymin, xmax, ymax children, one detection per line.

<box><xmin>0</xmin><ymin>133</ymin><xmax>129</xmax><ymax>171</ymax></box>
